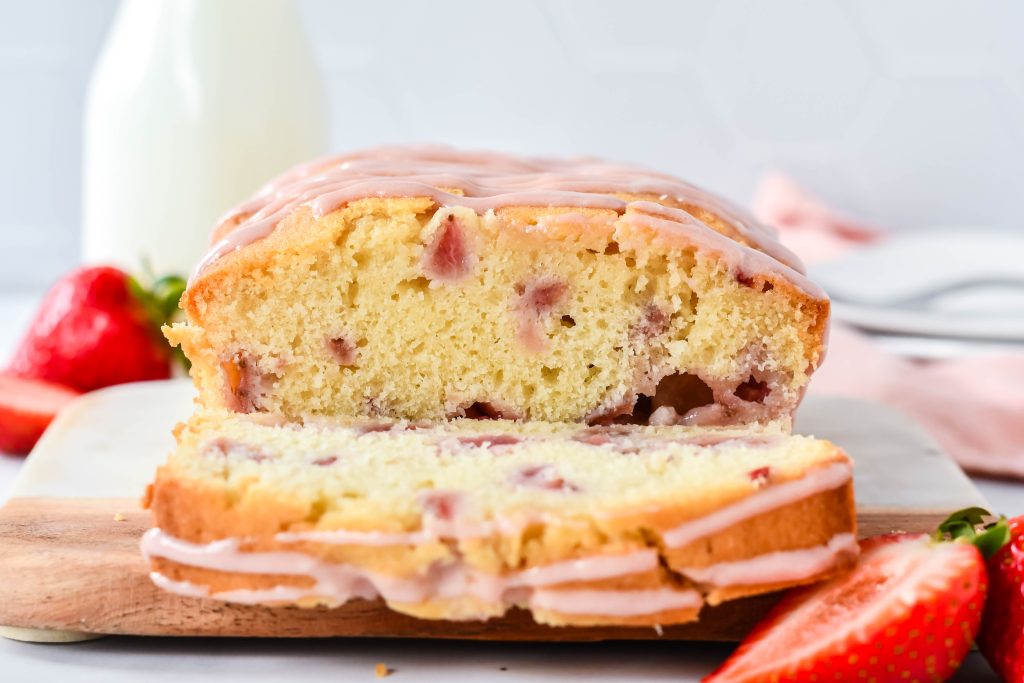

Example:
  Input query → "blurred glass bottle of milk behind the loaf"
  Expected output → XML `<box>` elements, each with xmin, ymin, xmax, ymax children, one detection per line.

<box><xmin>83</xmin><ymin>0</ymin><xmax>328</xmax><ymax>274</ymax></box>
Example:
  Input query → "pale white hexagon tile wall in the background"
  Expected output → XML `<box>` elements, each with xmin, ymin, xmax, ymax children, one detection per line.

<box><xmin>0</xmin><ymin>0</ymin><xmax>1024</xmax><ymax>287</ymax></box>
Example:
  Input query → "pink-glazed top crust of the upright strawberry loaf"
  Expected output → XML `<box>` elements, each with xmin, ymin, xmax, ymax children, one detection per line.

<box><xmin>190</xmin><ymin>146</ymin><xmax>824</xmax><ymax>298</ymax></box>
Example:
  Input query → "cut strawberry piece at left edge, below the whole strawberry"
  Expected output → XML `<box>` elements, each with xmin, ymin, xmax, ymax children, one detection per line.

<box><xmin>0</xmin><ymin>375</ymin><xmax>79</xmax><ymax>456</ymax></box>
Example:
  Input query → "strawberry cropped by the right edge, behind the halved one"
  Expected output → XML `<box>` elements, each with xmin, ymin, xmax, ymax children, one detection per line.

<box><xmin>978</xmin><ymin>516</ymin><xmax>1024</xmax><ymax>683</ymax></box>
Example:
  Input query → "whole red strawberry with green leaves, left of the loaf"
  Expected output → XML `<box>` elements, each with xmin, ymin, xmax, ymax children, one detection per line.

<box><xmin>9</xmin><ymin>266</ymin><xmax>183</xmax><ymax>391</ymax></box>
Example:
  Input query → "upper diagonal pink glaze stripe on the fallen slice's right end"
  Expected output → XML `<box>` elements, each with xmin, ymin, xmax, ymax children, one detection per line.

<box><xmin>662</xmin><ymin>463</ymin><xmax>853</xmax><ymax>548</ymax></box>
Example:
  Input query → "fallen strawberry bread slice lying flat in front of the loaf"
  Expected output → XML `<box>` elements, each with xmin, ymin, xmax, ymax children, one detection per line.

<box><xmin>142</xmin><ymin>412</ymin><xmax>857</xmax><ymax>625</ymax></box>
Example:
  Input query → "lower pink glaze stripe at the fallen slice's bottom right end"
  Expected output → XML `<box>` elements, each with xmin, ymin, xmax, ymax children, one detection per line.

<box><xmin>677</xmin><ymin>533</ymin><xmax>860</xmax><ymax>586</ymax></box>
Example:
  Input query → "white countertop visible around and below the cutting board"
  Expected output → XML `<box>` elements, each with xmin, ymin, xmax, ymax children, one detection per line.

<box><xmin>0</xmin><ymin>293</ymin><xmax>1011</xmax><ymax>683</ymax></box>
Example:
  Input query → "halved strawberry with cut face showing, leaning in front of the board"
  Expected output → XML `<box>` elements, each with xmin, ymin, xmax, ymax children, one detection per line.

<box><xmin>705</xmin><ymin>508</ymin><xmax>1005</xmax><ymax>683</ymax></box>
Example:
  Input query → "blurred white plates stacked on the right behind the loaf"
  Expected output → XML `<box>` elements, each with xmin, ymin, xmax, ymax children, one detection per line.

<box><xmin>810</xmin><ymin>228</ymin><xmax>1024</xmax><ymax>344</ymax></box>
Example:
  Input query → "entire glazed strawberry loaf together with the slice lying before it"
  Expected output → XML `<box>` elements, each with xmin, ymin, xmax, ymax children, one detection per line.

<box><xmin>142</xmin><ymin>147</ymin><xmax>857</xmax><ymax>626</ymax></box>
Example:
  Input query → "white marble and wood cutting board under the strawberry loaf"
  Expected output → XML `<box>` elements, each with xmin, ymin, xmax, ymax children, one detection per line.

<box><xmin>0</xmin><ymin>381</ymin><xmax>984</xmax><ymax>641</ymax></box>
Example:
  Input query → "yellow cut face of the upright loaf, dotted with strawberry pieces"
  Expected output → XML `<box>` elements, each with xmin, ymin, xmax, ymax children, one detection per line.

<box><xmin>166</xmin><ymin>199</ymin><xmax>827</xmax><ymax>424</ymax></box>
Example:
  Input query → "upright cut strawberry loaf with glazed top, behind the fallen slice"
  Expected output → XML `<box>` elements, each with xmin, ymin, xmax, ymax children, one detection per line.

<box><xmin>167</xmin><ymin>148</ymin><xmax>828</xmax><ymax>425</ymax></box>
